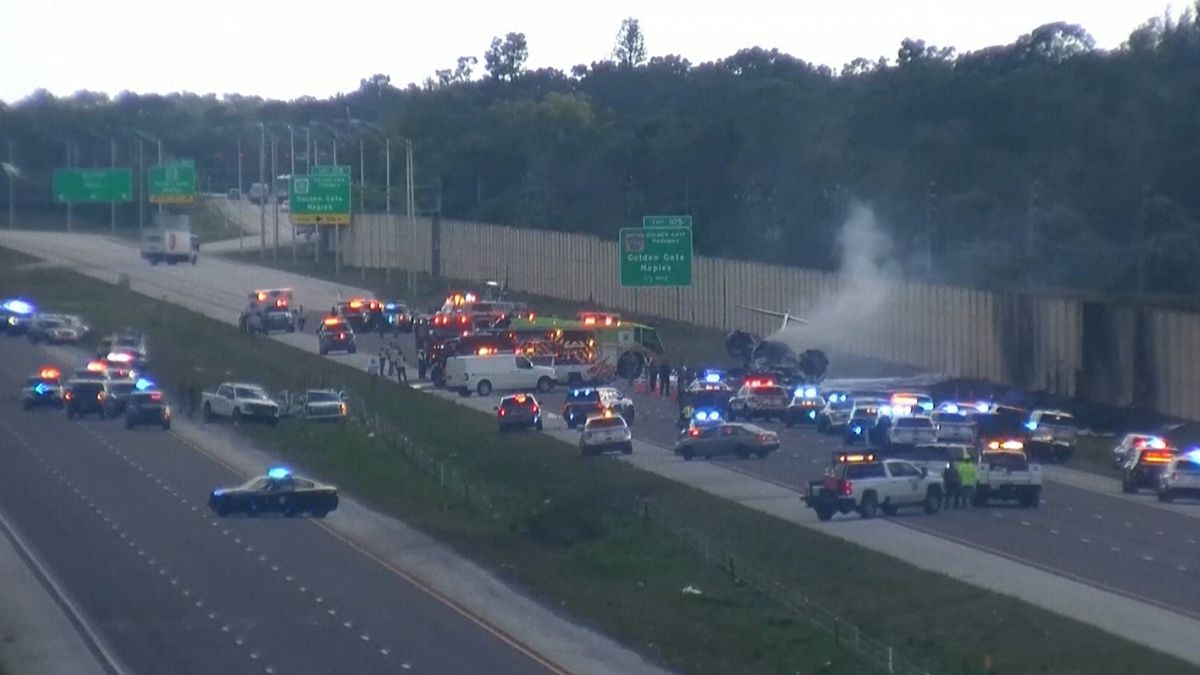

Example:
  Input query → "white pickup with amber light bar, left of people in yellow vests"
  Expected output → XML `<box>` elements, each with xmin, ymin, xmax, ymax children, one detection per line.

<box><xmin>804</xmin><ymin>452</ymin><xmax>943</xmax><ymax>521</ymax></box>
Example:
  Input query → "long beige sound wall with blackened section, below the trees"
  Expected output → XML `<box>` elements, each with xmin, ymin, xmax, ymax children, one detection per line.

<box><xmin>343</xmin><ymin>215</ymin><xmax>1200</xmax><ymax>419</ymax></box>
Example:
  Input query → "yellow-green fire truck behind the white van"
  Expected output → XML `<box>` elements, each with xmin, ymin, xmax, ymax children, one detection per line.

<box><xmin>508</xmin><ymin>312</ymin><xmax>665</xmax><ymax>381</ymax></box>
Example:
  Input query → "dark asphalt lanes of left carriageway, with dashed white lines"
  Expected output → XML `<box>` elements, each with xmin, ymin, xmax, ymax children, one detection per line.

<box><xmin>0</xmin><ymin>338</ymin><xmax>551</xmax><ymax>675</ymax></box>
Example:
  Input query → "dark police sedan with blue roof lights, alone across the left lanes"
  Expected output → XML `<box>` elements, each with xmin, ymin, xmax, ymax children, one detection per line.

<box><xmin>209</xmin><ymin>468</ymin><xmax>337</xmax><ymax>518</ymax></box>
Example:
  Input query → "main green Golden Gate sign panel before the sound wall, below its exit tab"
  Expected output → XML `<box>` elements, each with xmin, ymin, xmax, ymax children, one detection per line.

<box><xmin>619</xmin><ymin>227</ymin><xmax>691</xmax><ymax>287</ymax></box>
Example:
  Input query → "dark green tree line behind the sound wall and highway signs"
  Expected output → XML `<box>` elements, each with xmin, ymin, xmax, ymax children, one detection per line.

<box><xmin>0</xmin><ymin>4</ymin><xmax>1200</xmax><ymax>294</ymax></box>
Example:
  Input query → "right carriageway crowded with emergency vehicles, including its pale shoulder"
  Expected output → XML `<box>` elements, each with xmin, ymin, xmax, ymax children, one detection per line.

<box><xmin>7</xmin><ymin>228</ymin><xmax>1200</xmax><ymax>658</ymax></box>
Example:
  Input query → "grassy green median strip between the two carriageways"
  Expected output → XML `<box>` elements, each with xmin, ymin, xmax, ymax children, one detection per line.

<box><xmin>0</xmin><ymin>242</ymin><xmax>1194</xmax><ymax>674</ymax></box>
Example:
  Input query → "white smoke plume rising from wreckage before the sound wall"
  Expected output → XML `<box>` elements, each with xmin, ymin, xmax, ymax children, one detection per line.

<box><xmin>772</xmin><ymin>201</ymin><xmax>900</xmax><ymax>351</ymax></box>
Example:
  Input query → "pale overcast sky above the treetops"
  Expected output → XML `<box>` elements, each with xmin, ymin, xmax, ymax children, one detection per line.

<box><xmin>0</xmin><ymin>0</ymin><xmax>1190</xmax><ymax>103</ymax></box>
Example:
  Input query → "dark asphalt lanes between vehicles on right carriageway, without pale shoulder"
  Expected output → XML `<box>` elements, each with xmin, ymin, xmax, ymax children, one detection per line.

<box><xmin>350</xmin><ymin>326</ymin><xmax>1200</xmax><ymax>619</ymax></box>
